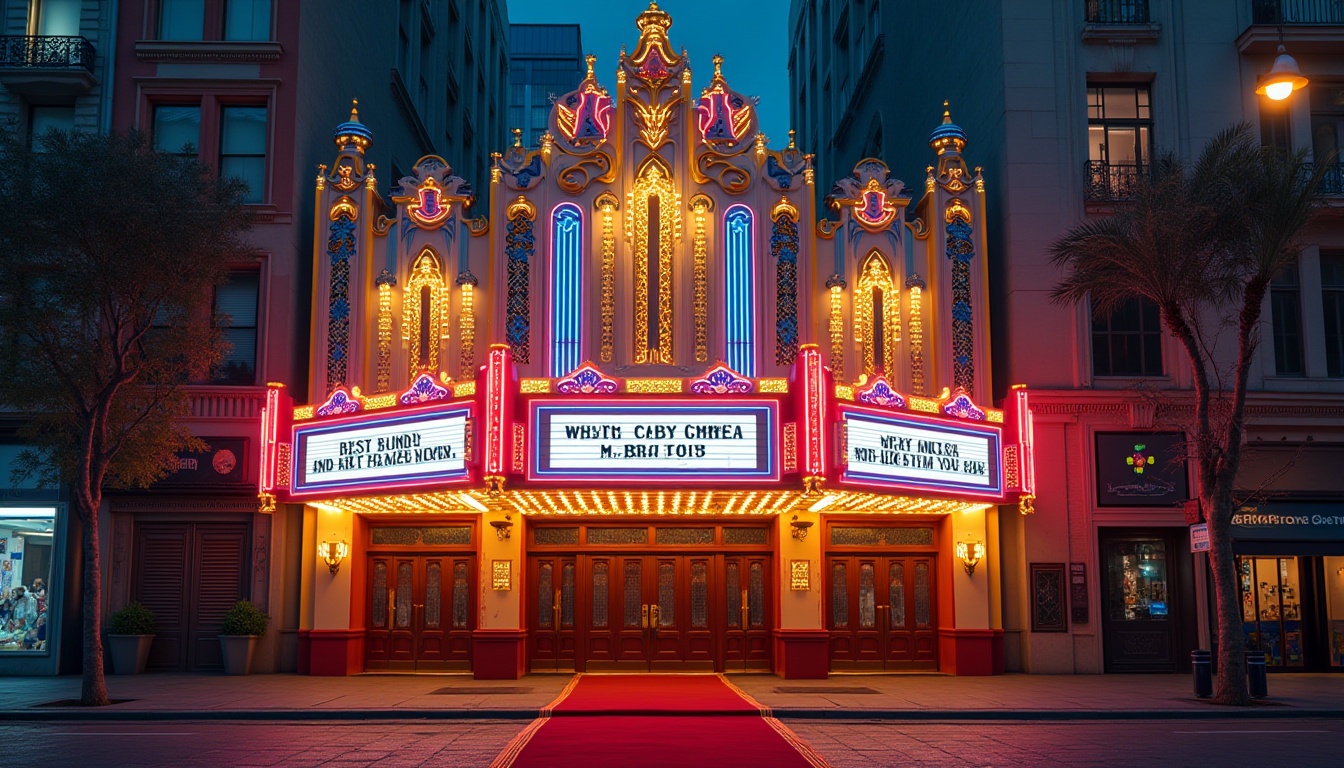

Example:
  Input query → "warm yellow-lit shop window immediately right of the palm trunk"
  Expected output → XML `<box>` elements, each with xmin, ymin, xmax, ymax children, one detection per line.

<box><xmin>1236</xmin><ymin>557</ymin><xmax>1306</xmax><ymax>667</ymax></box>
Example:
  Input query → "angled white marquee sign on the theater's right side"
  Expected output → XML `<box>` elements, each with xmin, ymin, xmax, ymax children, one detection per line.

<box><xmin>840</xmin><ymin>410</ymin><xmax>1003</xmax><ymax>496</ymax></box>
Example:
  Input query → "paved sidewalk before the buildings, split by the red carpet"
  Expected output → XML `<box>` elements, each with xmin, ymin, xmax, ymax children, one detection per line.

<box><xmin>0</xmin><ymin>674</ymin><xmax>1344</xmax><ymax>721</ymax></box>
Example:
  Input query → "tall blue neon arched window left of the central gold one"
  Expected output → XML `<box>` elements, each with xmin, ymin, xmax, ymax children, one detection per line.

<box><xmin>551</xmin><ymin>203</ymin><xmax>583</xmax><ymax>377</ymax></box>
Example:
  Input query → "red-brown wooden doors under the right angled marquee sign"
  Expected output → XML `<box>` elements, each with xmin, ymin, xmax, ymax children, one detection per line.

<box><xmin>827</xmin><ymin>554</ymin><xmax>938</xmax><ymax>670</ymax></box>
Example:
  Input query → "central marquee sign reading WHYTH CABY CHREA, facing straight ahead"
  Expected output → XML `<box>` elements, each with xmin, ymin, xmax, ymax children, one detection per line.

<box><xmin>528</xmin><ymin>401</ymin><xmax>778</xmax><ymax>483</ymax></box>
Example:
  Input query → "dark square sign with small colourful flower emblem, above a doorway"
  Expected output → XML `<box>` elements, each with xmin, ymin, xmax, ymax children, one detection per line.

<box><xmin>1097</xmin><ymin>432</ymin><xmax>1189</xmax><ymax>507</ymax></box>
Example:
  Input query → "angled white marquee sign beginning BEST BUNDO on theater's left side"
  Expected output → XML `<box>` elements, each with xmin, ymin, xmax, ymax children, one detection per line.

<box><xmin>290</xmin><ymin>404</ymin><xmax>470</xmax><ymax>495</ymax></box>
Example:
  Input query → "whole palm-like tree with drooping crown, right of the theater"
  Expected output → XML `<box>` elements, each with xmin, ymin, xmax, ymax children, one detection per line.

<box><xmin>1051</xmin><ymin>124</ymin><xmax>1333</xmax><ymax>705</ymax></box>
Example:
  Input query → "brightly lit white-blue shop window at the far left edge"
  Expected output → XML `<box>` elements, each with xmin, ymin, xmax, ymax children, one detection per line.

<box><xmin>0</xmin><ymin>507</ymin><xmax>56</xmax><ymax>652</ymax></box>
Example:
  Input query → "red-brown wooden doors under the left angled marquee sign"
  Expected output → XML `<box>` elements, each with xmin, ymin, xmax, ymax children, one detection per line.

<box><xmin>364</xmin><ymin>553</ymin><xmax>476</xmax><ymax>671</ymax></box>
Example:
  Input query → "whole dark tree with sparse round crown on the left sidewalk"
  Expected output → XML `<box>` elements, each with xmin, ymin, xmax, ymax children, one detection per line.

<box><xmin>0</xmin><ymin>130</ymin><xmax>253</xmax><ymax>706</ymax></box>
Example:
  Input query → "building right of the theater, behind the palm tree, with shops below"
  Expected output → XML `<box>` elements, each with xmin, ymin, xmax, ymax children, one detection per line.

<box><xmin>790</xmin><ymin>0</ymin><xmax>1344</xmax><ymax>673</ymax></box>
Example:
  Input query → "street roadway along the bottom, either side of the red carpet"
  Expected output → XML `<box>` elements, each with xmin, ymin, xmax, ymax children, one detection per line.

<box><xmin>0</xmin><ymin>718</ymin><xmax>1344</xmax><ymax>768</ymax></box>
